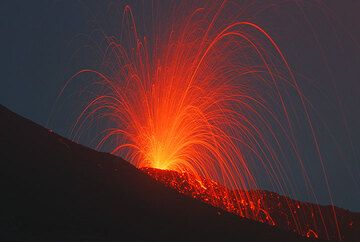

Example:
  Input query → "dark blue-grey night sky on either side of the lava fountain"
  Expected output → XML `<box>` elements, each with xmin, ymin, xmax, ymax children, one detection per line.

<box><xmin>0</xmin><ymin>0</ymin><xmax>360</xmax><ymax>211</ymax></box>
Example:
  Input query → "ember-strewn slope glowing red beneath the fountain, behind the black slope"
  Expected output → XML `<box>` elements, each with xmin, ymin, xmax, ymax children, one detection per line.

<box><xmin>142</xmin><ymin>168</ymin><xmax>360</xmax><ymax>241</ymax></box>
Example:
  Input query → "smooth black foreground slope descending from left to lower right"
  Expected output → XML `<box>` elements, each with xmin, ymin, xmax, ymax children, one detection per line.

<box><xmin>0</xmin><ymin>106</ymin><xmax>328</xmax><ymax>242</ymax></box>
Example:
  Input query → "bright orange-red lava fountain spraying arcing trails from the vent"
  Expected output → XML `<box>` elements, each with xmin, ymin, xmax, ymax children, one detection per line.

<box><xmin>58</xmin><ymin>1</ymin><xmax>348</xmax><ymax>238</ymax></box>
